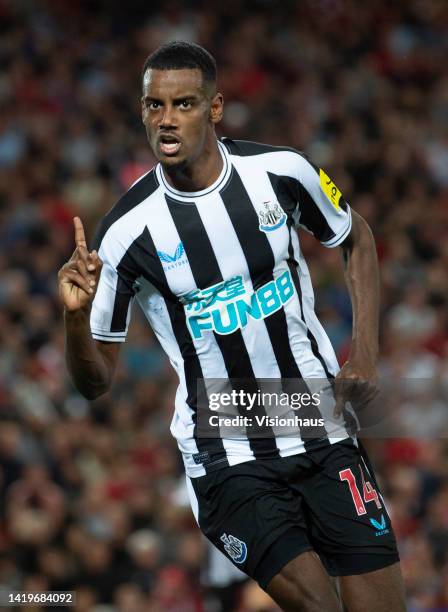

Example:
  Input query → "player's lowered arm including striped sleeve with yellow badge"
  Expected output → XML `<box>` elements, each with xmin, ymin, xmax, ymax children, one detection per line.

<box><xmin>293</xmin><ymin>155</ymin><xmax>379</xmax><ymax>416</ymax></box>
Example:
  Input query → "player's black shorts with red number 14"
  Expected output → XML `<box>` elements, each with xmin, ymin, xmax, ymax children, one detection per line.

<box><xmin>190</xmin><ymin>439</ymin><xmax>399</xmax><ymax>589</ymax></box>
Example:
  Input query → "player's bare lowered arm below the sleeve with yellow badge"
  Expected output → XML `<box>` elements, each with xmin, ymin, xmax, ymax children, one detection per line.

<box><xmin>335</xmin><ymin>210</ymin><xmax>379</xmax><ymax>416</ymax></box>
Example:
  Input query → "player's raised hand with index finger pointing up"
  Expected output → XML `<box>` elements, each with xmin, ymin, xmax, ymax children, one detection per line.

<box><xmin>58</xmin><ymin>217</ymin><xmax>103</xmax><ymax>312</ymax></box>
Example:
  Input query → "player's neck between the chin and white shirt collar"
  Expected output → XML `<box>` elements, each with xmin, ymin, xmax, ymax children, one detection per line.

<box><xmin>163</xmin><ymin>135</ymin><xmax>223</xmax><ymax>191</ymax></box>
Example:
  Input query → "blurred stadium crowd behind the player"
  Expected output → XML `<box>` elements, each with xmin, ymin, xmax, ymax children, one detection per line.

<box><xmin>0</xmin><ymin>0</ymin><xmax>448</xmax><ymax>612</ymax></box>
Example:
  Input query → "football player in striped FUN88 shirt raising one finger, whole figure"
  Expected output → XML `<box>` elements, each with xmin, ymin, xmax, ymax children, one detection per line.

<box><xmin>59</xmin><ymin>43</ymin><xmax>405</xmax><ymax>612</ymax></box>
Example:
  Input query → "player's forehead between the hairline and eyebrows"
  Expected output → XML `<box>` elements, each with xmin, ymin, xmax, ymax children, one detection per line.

<box><xmin>143</xmin><ymin>68</ymin><xmax>204</xmax><ymax>98</ymax></box>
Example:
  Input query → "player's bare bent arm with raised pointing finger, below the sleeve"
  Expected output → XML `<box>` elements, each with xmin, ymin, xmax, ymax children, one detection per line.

<box><xmin>58</xmin><ymin>217</ymin><xmax>120</xmax><ymax>399</ymax></box>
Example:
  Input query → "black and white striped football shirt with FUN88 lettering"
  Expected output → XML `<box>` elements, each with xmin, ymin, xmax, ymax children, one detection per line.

<box><xmin>91</xmin><ymin>138</ymin><xmax>351</xmax><ymax>477</ymax></box>
